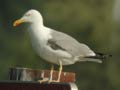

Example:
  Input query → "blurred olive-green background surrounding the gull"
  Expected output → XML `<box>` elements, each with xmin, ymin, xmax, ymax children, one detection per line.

<box><xmin>0</xmin><ymin>0</ymin><xmax>120</xmax><ymax>90</ymax></box>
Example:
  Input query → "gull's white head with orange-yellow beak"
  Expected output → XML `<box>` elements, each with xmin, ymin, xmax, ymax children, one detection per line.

<box><xmin>13</xmin><ymin>9</ymin><xmax>43</xmax><ymax>26</ymax></box>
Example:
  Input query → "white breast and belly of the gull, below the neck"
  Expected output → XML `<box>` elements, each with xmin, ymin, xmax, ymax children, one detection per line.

<box><xmin>29</xmin><ymin>27</ymin><xmax>73</xmax><ymax>64</ymax></box>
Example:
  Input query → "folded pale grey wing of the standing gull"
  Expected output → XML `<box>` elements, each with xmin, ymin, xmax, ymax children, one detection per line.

<box><xmin>51</xmin><ymin>30</ymin><xmax>95</xmax><ymax>57</ymax></box>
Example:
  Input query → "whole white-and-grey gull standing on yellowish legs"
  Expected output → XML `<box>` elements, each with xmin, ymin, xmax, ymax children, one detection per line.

<box><xmin>13</xmin><ymin>9</ymin><xmax>110</xmax><ymax>82</ymax></box>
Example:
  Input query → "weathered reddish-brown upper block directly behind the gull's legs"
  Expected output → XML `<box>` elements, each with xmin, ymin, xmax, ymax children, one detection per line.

<box><xmin>10</xmin><ymin>67</ymin><xmax>75</xmax><ymax>83</ymax></box>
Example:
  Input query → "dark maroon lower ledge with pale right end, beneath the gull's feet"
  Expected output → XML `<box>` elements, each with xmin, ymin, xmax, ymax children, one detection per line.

<box><xmin>0</xmin><ymin>81</ymin><xmax>78</xmax><ymax>90</ymax></box>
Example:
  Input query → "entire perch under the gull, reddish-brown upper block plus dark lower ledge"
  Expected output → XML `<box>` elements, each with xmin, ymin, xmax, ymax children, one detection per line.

<box><xmin>6</xmin><ymin>68</ymin><xmax>78</xmax><ymax>90</ymax></box>
